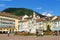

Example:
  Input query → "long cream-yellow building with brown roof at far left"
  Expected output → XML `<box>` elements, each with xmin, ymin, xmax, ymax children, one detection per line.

<box><xmin>0</xmin><ymin>12</ymin><xmax>18</xmax><ymax>33</ymax></box>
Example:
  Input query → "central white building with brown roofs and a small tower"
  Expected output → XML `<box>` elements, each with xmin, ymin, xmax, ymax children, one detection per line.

<box><xmin>19</xmin><ymin>12</ymin><xmax>44</xmax><ymax>33</ymax></box>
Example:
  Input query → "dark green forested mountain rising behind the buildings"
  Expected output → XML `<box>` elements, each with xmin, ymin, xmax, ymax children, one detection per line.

<box><xmin>2</xmin><ymin>8</ymin><xmax>45</xmax><ymax>17</ymax></box>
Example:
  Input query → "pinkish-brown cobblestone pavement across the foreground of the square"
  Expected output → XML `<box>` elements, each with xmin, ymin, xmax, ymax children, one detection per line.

<box><xmin>0</xmin><ymin>34</ymin><xmax>60</xmax><ymax>40</ymax></box>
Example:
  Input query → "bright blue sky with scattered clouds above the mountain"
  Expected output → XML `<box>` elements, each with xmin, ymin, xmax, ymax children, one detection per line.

<box><xmin>0</xmin><ymin>0</ymin><xmax>60</xmax><ymax>16</ymax></box>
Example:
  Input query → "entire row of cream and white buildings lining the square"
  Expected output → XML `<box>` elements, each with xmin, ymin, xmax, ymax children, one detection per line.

<box><xmin>0</xmin><ymin>12</ymin><xmax>60</xmax><ymax>33</ymax></box>
